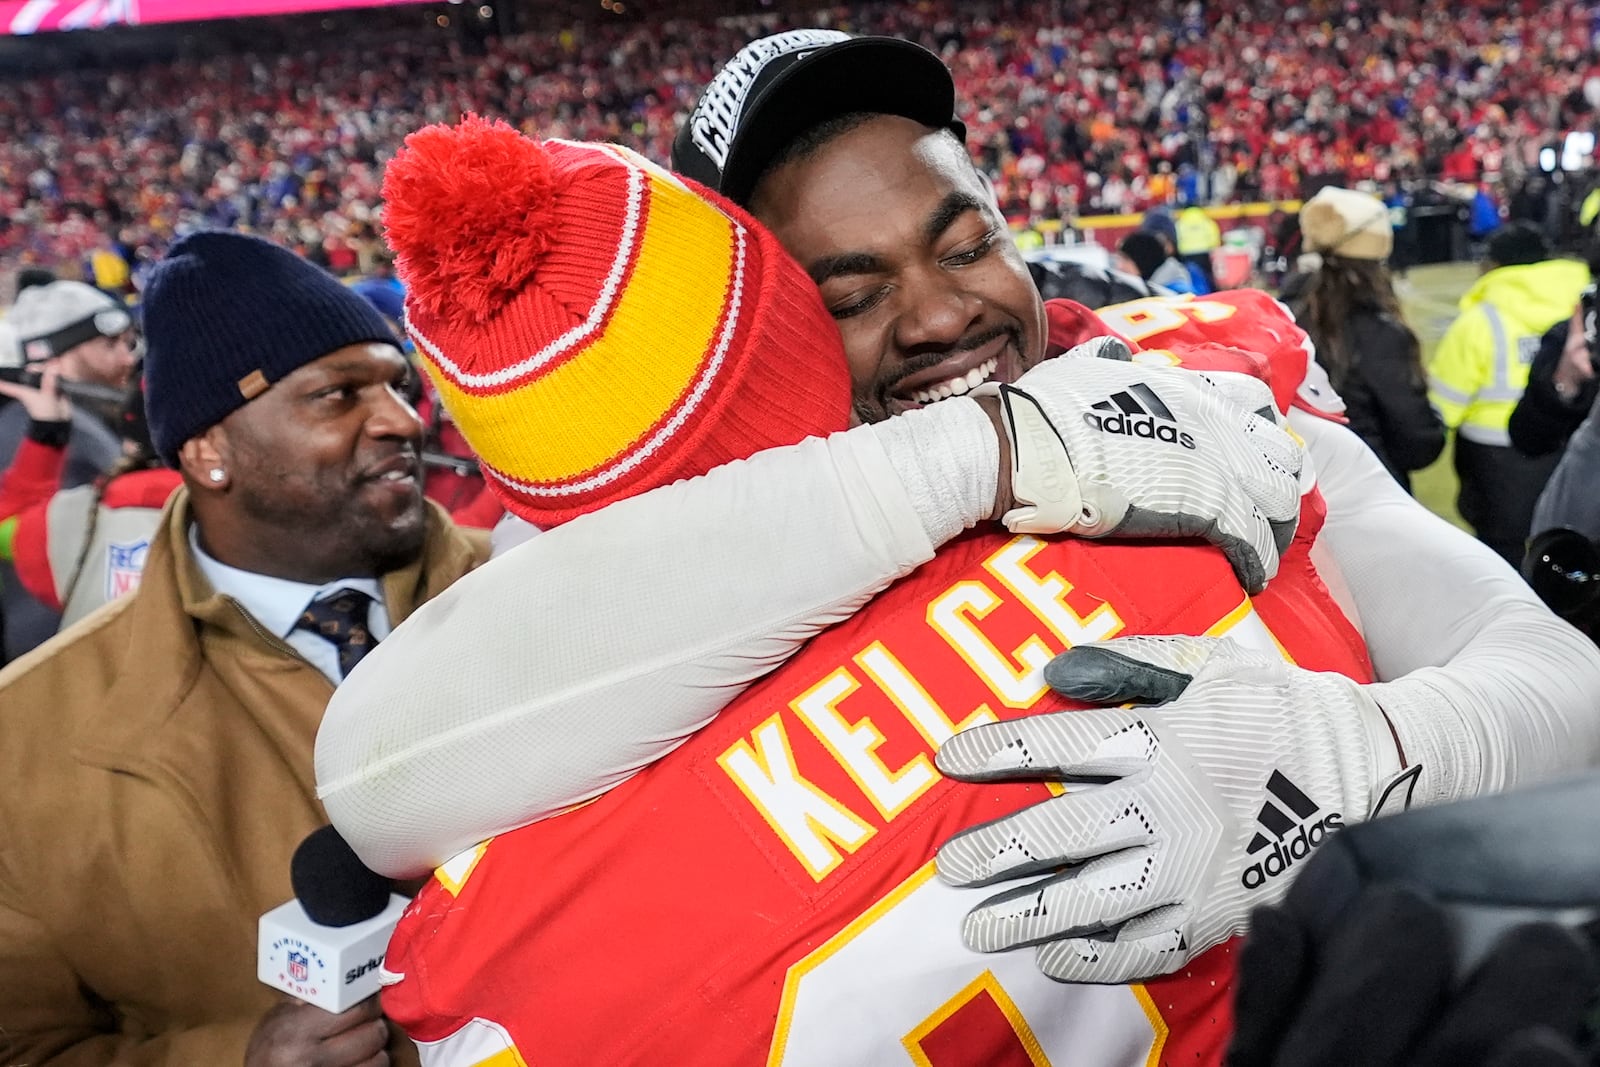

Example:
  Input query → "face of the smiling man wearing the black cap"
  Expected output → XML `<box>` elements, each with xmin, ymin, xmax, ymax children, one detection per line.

<box><xmin>750</xmin><ymin>115</ymin><xmax>1045</xmax><ymax>422</ymax></box>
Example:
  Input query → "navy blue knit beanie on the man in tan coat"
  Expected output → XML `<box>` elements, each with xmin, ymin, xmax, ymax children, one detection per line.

<box><xmin>142</xmin><ymin>230</ymin><xmax>398</xmax><ymax>467</ymax></box>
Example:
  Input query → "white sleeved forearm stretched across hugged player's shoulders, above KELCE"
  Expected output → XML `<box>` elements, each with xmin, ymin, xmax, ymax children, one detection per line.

<box><xmin>317</xmin><ymin>400</ymin><xmax>1000</xmax><ymax>877</ymax></box>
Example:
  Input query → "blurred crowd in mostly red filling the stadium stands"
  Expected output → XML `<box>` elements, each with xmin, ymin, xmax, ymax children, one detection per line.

<box><xmin>0</xmin><ymin>0</ymin><xmax>1600</xmax><ymax>288</ymax></box>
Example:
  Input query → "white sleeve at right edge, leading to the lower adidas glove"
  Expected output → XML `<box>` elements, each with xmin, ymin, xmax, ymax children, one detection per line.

<box><xmin>1290</xmin><ymin>411</ymin><xmax>1600</xmax><ymax>803</ymax></box>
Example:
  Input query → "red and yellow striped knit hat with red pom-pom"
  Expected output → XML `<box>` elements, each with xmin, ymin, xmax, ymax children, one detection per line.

<box><xmin>384</xmin><ymin>115</ymin><xmax>850</xmax><ymax>526</ymax></box>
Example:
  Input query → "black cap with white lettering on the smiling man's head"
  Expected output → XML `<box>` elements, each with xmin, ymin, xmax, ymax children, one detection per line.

<box><xmin>672</xmin><ymin>30</ymin><xmax>966</xmax><ymax>205</ymax></box>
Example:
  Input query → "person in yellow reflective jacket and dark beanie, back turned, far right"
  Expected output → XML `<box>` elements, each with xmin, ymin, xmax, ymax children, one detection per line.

<box><xmin>1427</xmin><ymin>222</ymin><xmax>1589</xmax><ymax>566</ymax></box>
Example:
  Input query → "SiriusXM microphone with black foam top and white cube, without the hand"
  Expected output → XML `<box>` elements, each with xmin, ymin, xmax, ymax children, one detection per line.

<box><xmin>256</xmin><ymin>825</ymin><xmax>408</xmax><ymax>1013</ymax></box>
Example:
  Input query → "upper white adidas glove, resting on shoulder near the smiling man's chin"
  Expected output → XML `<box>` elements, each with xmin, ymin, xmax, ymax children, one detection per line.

<box><xmin>971</xmin><ymin>338</ymin><xmax>1306</xmax><ymax>593</ymax></box>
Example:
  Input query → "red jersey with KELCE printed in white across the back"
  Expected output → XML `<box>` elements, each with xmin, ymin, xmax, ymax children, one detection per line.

<box><xmin>384</xmin><ymin>292</ymin><xmax>1370</xmax><ymax>1067</ymax></box>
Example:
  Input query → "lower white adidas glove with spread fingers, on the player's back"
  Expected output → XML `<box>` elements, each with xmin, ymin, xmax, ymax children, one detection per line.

<box><xmin>938</xmin><ymin>637</ymin><xmax>1421</xmax><ymax>982</ymax></box>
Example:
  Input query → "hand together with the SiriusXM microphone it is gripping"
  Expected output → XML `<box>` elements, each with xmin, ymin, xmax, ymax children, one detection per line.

<box><xmin>245</xmin><ymin>827</ymin><xmax>406</xmax><ymax>1067</ymax></box>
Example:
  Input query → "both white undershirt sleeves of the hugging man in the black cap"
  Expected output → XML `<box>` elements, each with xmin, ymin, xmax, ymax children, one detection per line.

<box><xmin>317</xmin><ymin>402</ymin><xmax>1600</xmax><ymax>877</ymax></box>
